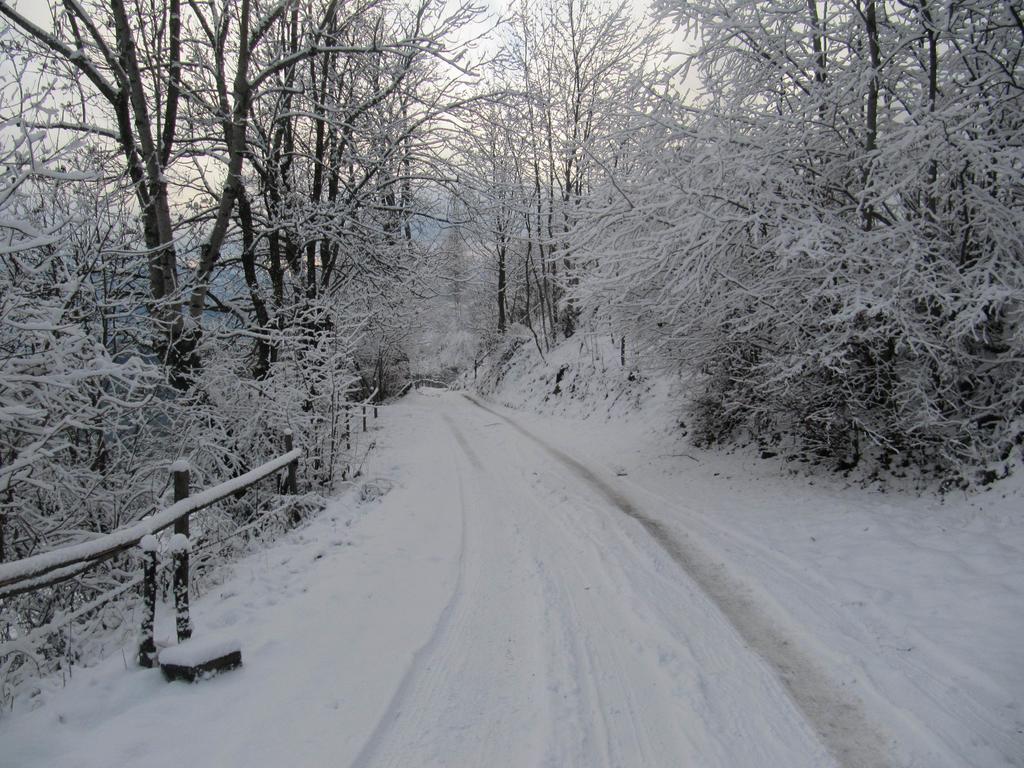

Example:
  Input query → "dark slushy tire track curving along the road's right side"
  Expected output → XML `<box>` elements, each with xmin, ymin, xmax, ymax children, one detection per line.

<box><xmin>463</xmin><ymin>393</ymin><xmax>891</xmax><ymax>768</ymax></box>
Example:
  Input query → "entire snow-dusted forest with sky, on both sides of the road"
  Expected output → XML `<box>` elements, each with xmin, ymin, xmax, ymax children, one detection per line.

<box><xmin>0</xmin><ymin>0</ymin><xmax>1024</xmax><ymax>702</ymax></box>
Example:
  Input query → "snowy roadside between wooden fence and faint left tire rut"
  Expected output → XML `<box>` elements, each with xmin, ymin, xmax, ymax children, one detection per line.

<box><xmin>0</xmin><ymin>411</ymin><xmax>460</xmax><ymax>768</ymax></box>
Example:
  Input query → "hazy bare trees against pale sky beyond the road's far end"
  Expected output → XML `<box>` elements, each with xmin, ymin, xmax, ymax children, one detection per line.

<box><xmin>452</xmin><ymin>0</ymin><xmax>666</xmax><ymax>348</ymax></box>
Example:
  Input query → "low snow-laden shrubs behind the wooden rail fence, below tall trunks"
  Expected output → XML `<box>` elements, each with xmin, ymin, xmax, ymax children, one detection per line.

<box><xmin>0</xmin><ymin>154</ymin><xmax>362</xmax><ymax>705</ymax></box>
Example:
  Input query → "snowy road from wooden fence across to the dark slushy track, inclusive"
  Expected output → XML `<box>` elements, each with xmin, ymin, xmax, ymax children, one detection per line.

<box><xmin>6</xmin><ymin>392</ymin><xmax>905</xmax><ymax>768</ymax></box>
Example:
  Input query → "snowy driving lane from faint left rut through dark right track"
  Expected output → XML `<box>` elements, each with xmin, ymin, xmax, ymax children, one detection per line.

<box><xmin>356</xmin><ymin>395</ymin><xmax>886</xmax><ymax>766</ymax></box>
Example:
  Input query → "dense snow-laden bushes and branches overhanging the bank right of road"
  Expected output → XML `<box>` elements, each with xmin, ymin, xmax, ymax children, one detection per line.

<box><xmin>575</xmin><ymin>0</ymin><xmax>1024</xmax><ymax>481</ymax></box>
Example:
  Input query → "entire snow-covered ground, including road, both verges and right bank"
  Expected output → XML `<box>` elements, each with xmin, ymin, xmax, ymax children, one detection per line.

<box><xmin>0</xmin><ymin>340</ymin><xmax>1024</xmax><ymax>768</ymax></box>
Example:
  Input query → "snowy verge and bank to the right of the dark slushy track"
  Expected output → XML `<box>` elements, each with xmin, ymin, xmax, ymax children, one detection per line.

<box><xmin>468</xmin><ymin>337</ymin><xmax>1024</xmax><ymax>767</ymax></box>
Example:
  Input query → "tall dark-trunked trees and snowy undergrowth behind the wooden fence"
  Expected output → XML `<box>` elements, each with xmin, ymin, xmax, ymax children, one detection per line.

<box><xmin>0</xmin><ymin>0</ymin><xmax>485</xmax><ymax>704</ymax></box>
